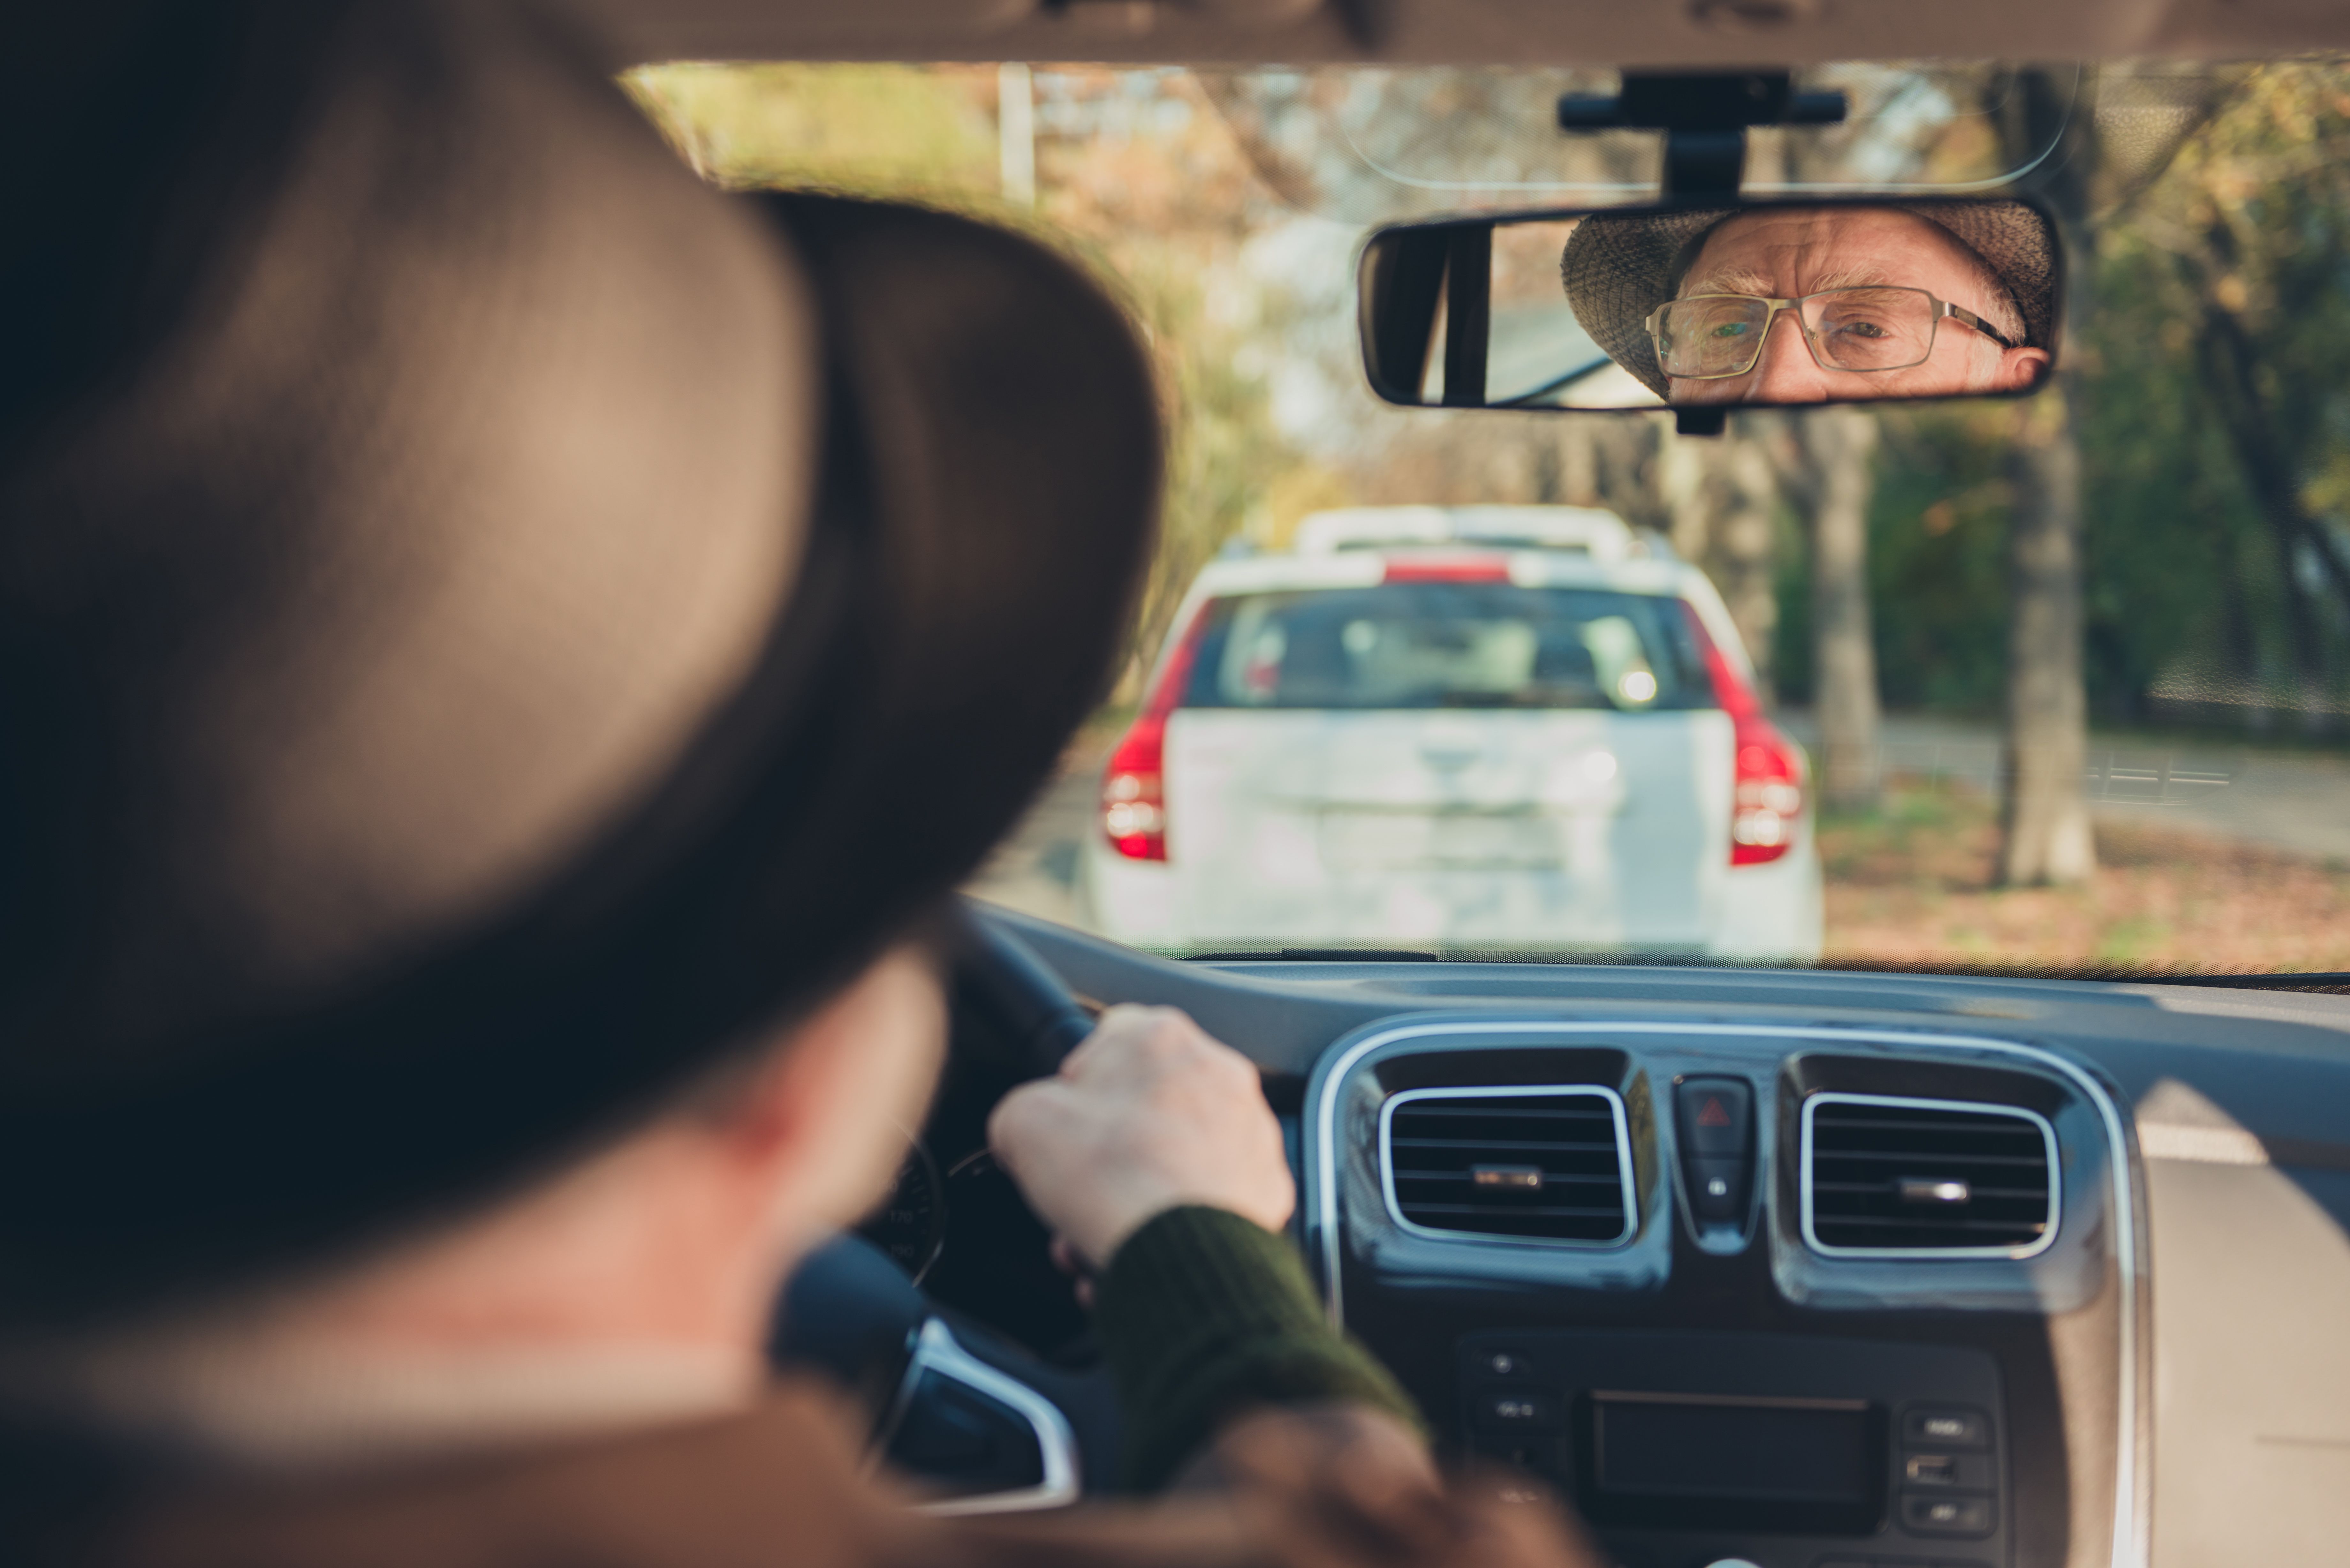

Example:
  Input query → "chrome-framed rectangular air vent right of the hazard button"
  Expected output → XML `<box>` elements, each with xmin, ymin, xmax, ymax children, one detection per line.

<box><xmin>1802</xmin><ymin>1093</ymin><xmax>2058</xmax><ymax>1258</ymax></box>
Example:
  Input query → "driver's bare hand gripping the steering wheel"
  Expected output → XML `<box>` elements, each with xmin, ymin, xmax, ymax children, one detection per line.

<box><xmin>987</xmin><ymin>1006</ymin><xmax>1297</xmax><ymax>1270</ymax></box>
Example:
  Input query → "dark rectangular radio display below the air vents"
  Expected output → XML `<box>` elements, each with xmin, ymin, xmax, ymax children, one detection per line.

<box><xmin>1577</xmin><ymin>1392</ymin><xmax>1885</xmax><ymax>1535</ymax></box>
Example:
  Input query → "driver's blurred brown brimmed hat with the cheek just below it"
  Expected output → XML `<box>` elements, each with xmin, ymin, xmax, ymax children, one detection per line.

<box><xmin>0</xmin><ymin>0</ymin><xmax>1158</xmax><ymax>1338</ymax></box>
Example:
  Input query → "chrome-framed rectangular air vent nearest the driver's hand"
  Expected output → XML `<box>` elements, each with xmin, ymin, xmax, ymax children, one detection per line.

<box><xmin>1379</xmin><ymin>1086</ymin><xmax>1633</xmax><ymax>1246</ymax></box>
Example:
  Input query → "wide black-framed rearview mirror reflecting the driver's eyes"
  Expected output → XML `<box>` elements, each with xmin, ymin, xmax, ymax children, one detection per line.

<box><xmin>1358</xmin><ymin>198</ymin><xmax>2061</xmax><ymax>426</ymax></box>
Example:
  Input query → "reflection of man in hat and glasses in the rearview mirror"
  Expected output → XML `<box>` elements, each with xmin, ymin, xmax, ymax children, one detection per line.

<box><xmin>1560</xmin><ymin>202</ymin><xmax>2056</xmax><ymax>404</ymax></box>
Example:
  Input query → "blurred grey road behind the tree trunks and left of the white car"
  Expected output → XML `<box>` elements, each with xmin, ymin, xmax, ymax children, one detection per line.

<box><xmin>971</xmin><ymin>712</ymin><xmax>2350</xmax><ymax>922</ymax></box>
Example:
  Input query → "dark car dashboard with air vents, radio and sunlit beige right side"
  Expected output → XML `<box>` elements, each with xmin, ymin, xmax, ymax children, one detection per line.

<box><xmin>832</xmin><ymin>912</ymin><xmax>2350</xmax><ymax>1568</ymax></box>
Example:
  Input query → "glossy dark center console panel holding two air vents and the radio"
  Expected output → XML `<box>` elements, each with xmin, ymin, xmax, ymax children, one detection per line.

<box><xmin>1302</xmin><ymin>1013</ymin><xmax>2143</xmax><ymax>1568</ymax></box>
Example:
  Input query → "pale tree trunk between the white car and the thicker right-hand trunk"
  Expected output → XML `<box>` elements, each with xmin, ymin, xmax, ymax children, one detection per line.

<box><xmin>1802</xmin><ymin>409</ymin><xmax>1885</xmax><ymax>811</ymax></box>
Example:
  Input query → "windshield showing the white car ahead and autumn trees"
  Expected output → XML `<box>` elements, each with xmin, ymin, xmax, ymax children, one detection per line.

<box><xmin>630</xmin><ymin>61</ymin><xmax>2350</xmax><ymax>976</ymax></box>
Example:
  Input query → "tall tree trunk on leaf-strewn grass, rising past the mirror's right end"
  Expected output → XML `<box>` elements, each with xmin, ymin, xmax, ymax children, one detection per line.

<box><xmin>2000</xmin><ymin>71</ymin><xmax>2096</xmax><ymax>886</ymax></box>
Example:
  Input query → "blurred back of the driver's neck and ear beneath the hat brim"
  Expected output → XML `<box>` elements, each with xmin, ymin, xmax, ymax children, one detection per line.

<box><xmin>0</xmin><ymin>1131</ymin><xmax>815</xmax><ymax>1472</ymax></box>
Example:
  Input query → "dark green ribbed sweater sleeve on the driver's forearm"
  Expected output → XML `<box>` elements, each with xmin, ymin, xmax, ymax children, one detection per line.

<box><xmin>1095</xmin><ymin>1206</ymin><xmax>1424</xmax><ymax>1490</ymax></box>
